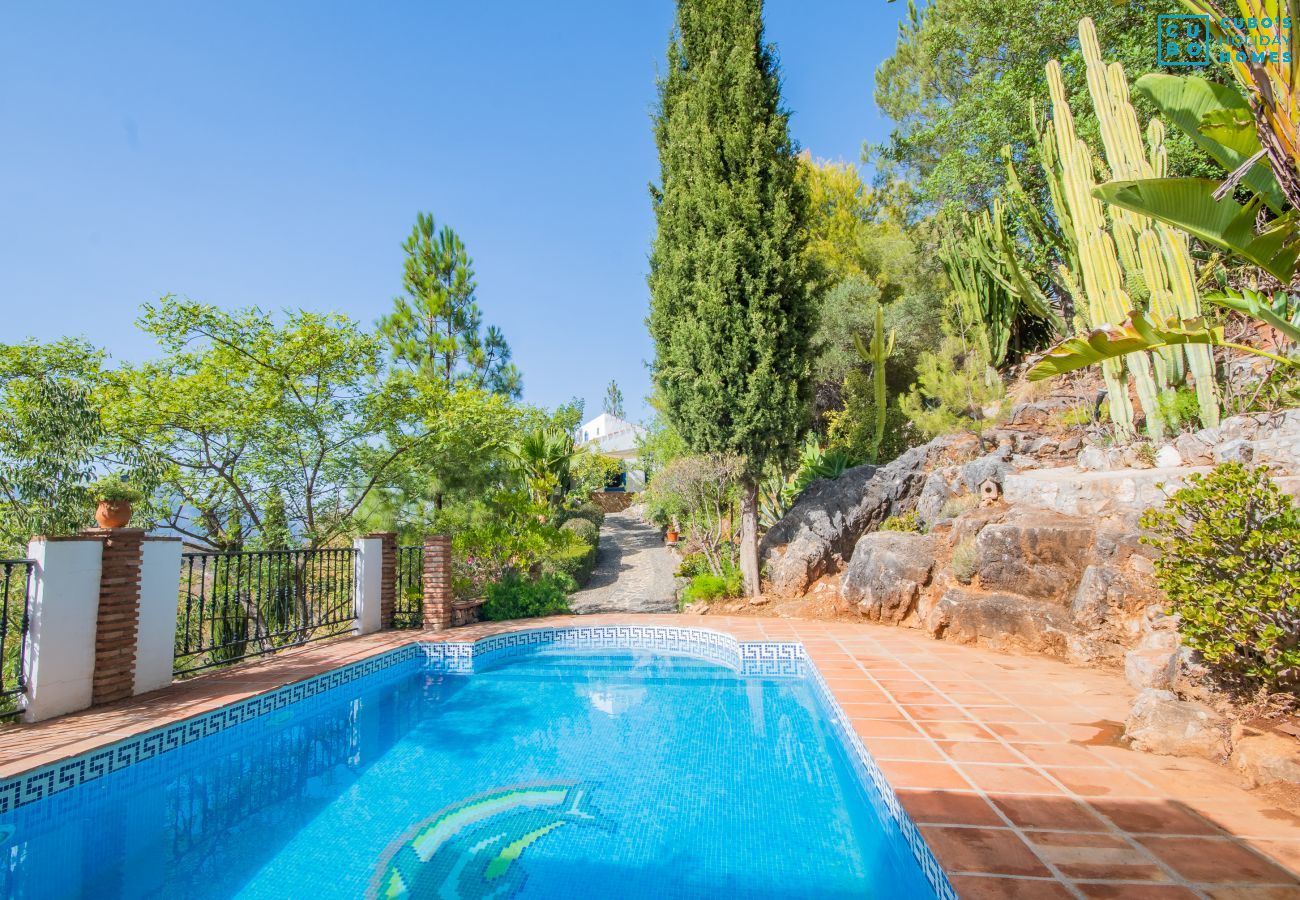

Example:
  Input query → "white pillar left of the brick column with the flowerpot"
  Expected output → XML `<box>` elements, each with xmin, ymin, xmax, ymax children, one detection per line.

<box><xmin>22</xmin><ymin>537</ymin><xmax>104</xmax><ymax>722</ymax></box>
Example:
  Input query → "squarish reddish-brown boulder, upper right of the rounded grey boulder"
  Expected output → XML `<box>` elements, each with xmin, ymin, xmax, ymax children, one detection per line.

<box><xmin>975</xmin><ymin>510</ymin><xmax>1093</xmax><ymax>601</ymax></box>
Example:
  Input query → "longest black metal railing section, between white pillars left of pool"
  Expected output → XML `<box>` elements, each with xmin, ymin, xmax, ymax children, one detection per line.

<box><xmin>174</xmin><ymin>548</ymin><xmax>356</xmax><ymax>675</ymax></box>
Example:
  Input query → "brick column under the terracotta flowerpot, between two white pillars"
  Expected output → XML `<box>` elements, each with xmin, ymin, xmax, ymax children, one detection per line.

<box><xmin>85</xmin><ymin>528</ymin><xmax>144</xmax><ymax>705</ymax></box>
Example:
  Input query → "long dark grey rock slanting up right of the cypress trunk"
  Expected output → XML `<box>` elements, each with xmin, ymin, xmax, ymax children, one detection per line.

<box><xmin>758</xmin><ymin>436</ymin><xmax>961</xmax><ymax>597</ymax></box>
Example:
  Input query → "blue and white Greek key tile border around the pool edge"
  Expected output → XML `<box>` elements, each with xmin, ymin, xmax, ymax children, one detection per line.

<box><xmin>0</xmin><ymin>626</ymin><xmax>957</xmax><ymax>900</ymax></box>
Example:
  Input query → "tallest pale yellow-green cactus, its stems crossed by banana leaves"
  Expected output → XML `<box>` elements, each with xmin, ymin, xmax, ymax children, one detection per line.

<box><xmin>1079</xmin><ymin>18</ymin><xmax>1219</xmax><ymax>427</ymax></box>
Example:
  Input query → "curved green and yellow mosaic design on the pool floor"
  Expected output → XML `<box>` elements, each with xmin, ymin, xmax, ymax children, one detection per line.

<box><xmin>368</xmin><ymin>783</ymin><xmax>601</xmax><ymax>900</ymax></box>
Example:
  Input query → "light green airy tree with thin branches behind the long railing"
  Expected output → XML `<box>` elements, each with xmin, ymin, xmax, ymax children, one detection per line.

<box><xmin>104</xmin><ymin>297</ymin><xmax>433</xmax><ymax>550</ymax></box>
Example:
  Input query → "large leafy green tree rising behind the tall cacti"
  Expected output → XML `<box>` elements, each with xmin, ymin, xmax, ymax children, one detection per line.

<box><xmin>874</xmin><ymin>0</ymin><xmax>1226</xmax><ymax>215</ymax></box>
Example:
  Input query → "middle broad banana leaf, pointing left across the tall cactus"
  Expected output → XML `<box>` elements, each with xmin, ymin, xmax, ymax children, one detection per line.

<box><xmin>1093</xmin><ymin>178</ymin><xmax>1300</xmax><ymax>284</ymax></box>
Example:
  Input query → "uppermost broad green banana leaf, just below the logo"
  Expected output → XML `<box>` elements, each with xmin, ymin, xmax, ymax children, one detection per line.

<box><xmin>1134</xmin><ymin>73</ymin><xmax>1286</xmax><ymax>215</ymax></box>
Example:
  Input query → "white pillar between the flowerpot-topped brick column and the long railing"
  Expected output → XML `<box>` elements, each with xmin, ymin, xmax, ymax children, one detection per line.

<box><xmin>133</xmin><ymin>537</ymin><xmax>181</xmax><ymax>693</ymax></box>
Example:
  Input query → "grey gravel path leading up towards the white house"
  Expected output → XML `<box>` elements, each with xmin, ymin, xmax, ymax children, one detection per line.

<box><xmin>569</xmin><ymin>512</ymin><xmax>677</xmax><ymax>614</ymax></box>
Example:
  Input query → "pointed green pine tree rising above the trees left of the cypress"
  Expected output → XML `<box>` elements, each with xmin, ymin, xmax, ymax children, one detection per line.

<box><xmin>380</xmin><ymin>213</ymin><xmax>523</xmax><ymax>398</ymax></box>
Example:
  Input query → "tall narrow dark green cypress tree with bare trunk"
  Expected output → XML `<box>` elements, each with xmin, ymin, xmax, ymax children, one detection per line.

<box><xmin>649</xmin><ymin>0</ymin><xmax>814</xmax><ymax>594</ymax></box>
